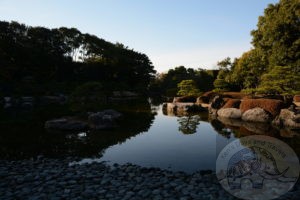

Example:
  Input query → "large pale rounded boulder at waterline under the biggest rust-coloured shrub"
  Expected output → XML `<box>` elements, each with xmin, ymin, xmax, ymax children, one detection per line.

<box><xmin>242</xmin><ymin>107</ymin><xmax>272</xmax><ymax>122</ymax></box>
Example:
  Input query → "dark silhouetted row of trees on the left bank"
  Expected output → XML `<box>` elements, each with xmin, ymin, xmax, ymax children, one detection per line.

<box><xmin>0</xmin><ymin>21</ymin><xmax>155</xmax><ymax>96</ymax></box>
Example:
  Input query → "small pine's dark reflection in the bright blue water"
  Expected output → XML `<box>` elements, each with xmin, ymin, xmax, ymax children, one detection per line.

<box><xmin>177</xmin><ymin>115</ymin><xmax>201</xmax><ymax>134</ymax></box>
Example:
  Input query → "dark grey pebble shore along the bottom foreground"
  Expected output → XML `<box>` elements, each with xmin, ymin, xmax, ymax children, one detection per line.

<box><xmin>0</xmin><ymin>158</ymin><xmax>300</xmax><ymax>200</ymax></box>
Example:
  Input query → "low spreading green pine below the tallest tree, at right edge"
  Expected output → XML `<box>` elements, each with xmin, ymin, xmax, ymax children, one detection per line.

<box><xmin>258</xmin><ymin>66</ymin><xmax>300</xmax><ymax>94</ymax></box>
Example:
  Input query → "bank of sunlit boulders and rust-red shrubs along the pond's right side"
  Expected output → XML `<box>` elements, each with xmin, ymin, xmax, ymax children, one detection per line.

<box><xmin>163</xmin><ymin>92</ymin><xmax>300</xmax><ymax>129</ymax></box>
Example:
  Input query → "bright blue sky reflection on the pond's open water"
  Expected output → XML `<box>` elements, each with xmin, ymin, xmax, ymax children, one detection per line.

<box><xmin>100</xmin><ymin>104</ymin><xmax>226</xmax><ymax>172</ymax></box>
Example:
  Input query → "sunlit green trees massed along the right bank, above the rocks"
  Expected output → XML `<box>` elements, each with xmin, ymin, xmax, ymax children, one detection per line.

<box><xmin>214</xmin><ymin>0</ymin><xmax>300</xmax><ymax>94</ymax></box>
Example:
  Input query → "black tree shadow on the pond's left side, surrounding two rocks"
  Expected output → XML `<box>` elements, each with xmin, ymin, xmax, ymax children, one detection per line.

<box><xmin>0</xmin><ymin>99</ymin><xmax>156</xmax><ymax>159</ymax></box>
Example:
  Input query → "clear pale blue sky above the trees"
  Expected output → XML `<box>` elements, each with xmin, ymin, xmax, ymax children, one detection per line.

<box><xmin>0</xmin><ymin>0</ymin><xmax>279</xmax><ymax>72</ymax></box>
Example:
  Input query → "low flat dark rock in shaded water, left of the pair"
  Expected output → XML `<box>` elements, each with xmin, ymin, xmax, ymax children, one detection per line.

<box><xmin>45</xmin><ymin>118</ymin><xmax>88</xmax><ymax>131</ymax></box>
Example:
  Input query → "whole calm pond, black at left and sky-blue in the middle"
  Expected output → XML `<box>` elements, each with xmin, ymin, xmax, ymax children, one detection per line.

<box><xmin>0</xmin><ymin>102</ymin><xmax>300</xmax><ymax>173</ymax></box>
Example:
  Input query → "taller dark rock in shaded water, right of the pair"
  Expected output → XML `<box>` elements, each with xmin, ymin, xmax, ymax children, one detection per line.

<box><xmin>88</xmin><ymin>109</ymin><xmax>122</xmax><ymax>130</ymax></box>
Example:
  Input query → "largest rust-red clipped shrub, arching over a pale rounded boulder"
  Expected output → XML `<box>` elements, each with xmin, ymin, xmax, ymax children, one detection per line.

<box><xmin>240</xmin><ymin>99</ymin><xmax>284</xmax><ymax>118</ymax></box>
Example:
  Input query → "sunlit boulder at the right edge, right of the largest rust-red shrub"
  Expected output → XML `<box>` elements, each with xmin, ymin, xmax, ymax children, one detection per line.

<box><xmin>273</xmin><ymin>109</ymin><xmax>300</xmax><ymax>128</ymax></box>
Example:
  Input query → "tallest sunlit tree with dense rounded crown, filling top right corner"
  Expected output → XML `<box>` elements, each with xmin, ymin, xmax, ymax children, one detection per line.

<box><xmin>251</xmin><ymin>0</ymin><xmax>300</xmax><ymax>71</ymax></box>
